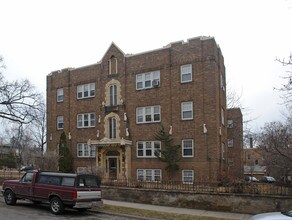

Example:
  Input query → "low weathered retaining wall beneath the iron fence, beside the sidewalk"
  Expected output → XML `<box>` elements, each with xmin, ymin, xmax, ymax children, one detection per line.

<box><xmin>102</xmin><ymin>187</ymin><xmax>292</xmax><ymax>214</ymax></box>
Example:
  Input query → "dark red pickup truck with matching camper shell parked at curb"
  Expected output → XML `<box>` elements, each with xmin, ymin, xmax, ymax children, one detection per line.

<box><xmin>2</xmin><ymin>170</ymin><xmax>103</xmax><ymax>214</ymax></box>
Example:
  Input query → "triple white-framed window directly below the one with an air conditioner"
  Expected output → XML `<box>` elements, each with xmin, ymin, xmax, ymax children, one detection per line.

<box><xmin>136</xmin><ymin>105</ymin><xmax>160</xmax><ymax>124</ymax></box>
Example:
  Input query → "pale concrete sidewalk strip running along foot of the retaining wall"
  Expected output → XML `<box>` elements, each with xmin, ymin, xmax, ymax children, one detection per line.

<box><xmin>103</xmin><ymin>199</ymin><xmax>251</xmax><ymax>220</ymax></box>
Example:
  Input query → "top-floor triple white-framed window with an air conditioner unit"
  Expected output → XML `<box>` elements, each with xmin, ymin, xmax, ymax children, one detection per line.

<box><xmin>136</xmin><ymin>70</ymin><xmax>160</xmax><ymax>90</ymax></box>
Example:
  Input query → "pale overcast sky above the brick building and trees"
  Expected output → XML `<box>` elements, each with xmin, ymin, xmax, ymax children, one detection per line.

<box><xmin>0</xmin><ymin>0</ymin><xmax>292</xmax><ymax>129</ymax></box>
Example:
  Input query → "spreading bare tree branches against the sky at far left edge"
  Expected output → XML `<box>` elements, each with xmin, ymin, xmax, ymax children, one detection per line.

<box><xmin>0</xmin><ymin>57</ymin><xmax>42</xmax><ymax>124</ymax></box>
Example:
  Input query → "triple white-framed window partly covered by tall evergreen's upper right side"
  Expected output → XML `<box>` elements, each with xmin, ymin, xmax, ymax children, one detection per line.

<box><xmin>137</xmin><ymin>141</ymin><xmax>161</xmax><ymax>158</ymax></box>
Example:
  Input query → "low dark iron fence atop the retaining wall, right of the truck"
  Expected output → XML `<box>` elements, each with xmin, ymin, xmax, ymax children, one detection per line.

<box><xmin>101</xmin><ymin>179</ymin><xmax>292</xmax><ymax>196</ymax></box>
